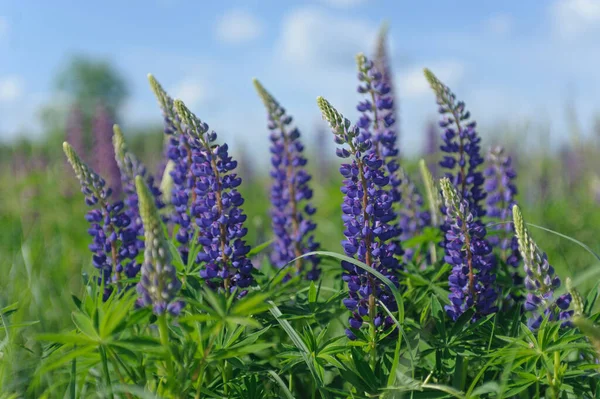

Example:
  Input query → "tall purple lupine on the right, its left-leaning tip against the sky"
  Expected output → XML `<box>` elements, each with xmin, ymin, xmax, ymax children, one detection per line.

<box><xmin>425</xmin><ymin>69</ymin><xmax>486</xmax><ymax>218</ymax></box>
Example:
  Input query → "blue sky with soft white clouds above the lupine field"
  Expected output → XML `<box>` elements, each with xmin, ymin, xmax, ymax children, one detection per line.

<box><xmin>0</xmin><ymin>0</ymin><xmax>600</xmax><ymax>156</ymax></box>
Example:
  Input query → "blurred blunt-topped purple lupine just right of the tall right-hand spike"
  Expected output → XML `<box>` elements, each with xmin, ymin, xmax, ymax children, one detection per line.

<box><xmin>484</xmin><ymin>147</ymin><xmax>520</xmax><ymax>272</ymax></box>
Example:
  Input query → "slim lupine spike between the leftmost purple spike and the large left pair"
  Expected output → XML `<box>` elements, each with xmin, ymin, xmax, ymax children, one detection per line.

<box><xmin>113</xmin><ymin>125</ymin><xmax>165</xmax><ymax>278</ymax></box>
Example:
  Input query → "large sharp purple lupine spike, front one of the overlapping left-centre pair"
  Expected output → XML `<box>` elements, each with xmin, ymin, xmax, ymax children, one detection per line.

<box><xmin>174</xmin><ymin>100</ymin><xmax>254</xmax><ymax>296</ymax></box>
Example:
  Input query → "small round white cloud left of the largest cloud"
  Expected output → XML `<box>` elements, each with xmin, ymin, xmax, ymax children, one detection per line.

<box><xmin>215</xmin><ymin>9</ymin><xmax>263</xmax><ymax>44</ymax></box>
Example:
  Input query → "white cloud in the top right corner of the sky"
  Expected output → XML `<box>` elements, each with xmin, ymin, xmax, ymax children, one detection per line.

<box><xmin>550</xmin><ymin>0</ymin><xmax>600</xmax><ymax>37</ymax></box>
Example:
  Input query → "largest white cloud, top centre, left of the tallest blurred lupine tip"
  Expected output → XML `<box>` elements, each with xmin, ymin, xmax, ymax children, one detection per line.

<box><xmin>277</xmin><ymin>7</ymin><xmax>377</xmax><ymax>69</ymax></box>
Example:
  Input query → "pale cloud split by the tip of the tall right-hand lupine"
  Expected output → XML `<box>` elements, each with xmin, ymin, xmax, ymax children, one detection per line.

<box><xmin>398</xmin><ymin>61</ymin><xmax>465</xmax><ymax>98</ymax></box>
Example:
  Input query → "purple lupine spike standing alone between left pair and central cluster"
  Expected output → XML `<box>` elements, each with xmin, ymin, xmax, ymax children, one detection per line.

<box><xmin>254</xmin><ymin>79</ymin><xmax>320</xmax><ymax>280</ymax></box>
